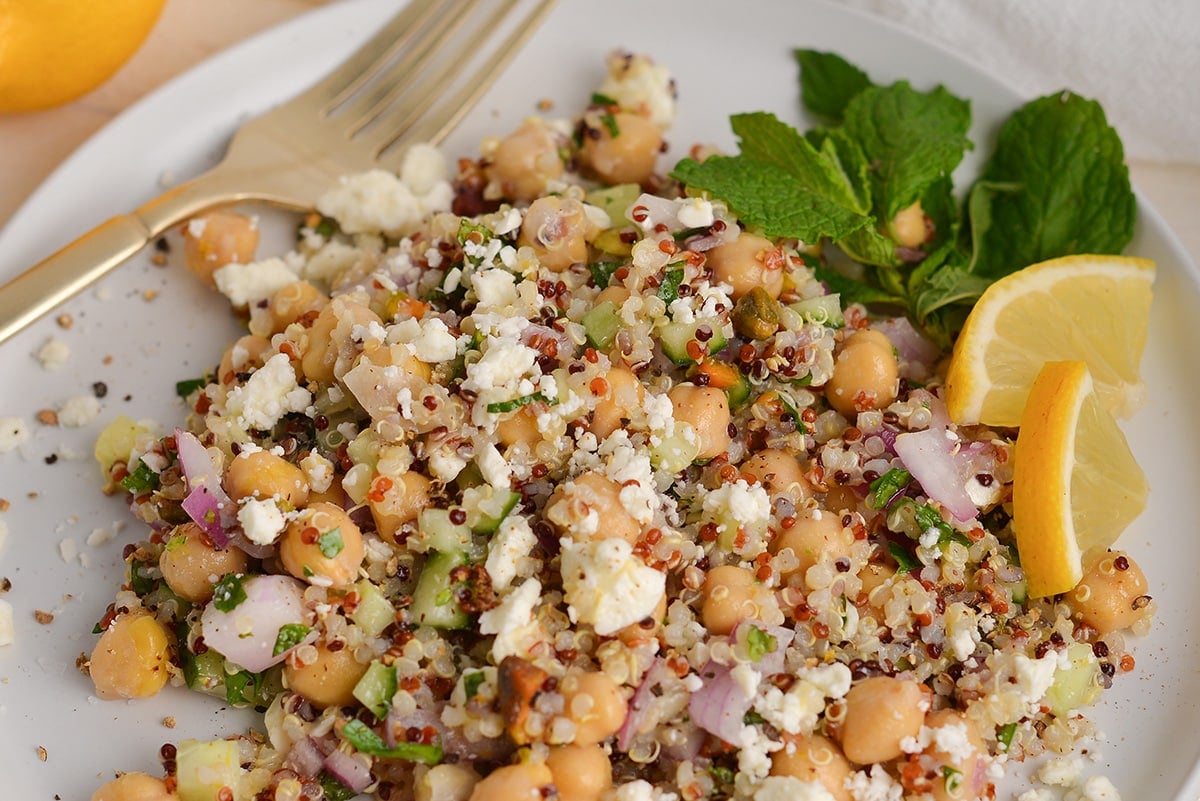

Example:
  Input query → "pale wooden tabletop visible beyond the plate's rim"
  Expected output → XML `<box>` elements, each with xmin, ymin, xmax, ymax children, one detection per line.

<box><xmin>0</xmin><ymin>0</ymin><xmax>1200</xmax><ymax>272</ymax></box>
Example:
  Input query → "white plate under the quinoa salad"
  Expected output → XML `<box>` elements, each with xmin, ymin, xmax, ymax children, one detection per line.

<box><xmin>0</xmin><ymin>0</ymin><xmax>1200</xmax><ymax>801</ymax></box>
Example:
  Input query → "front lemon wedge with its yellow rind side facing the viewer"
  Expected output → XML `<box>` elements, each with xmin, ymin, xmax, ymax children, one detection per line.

<box><xmin>1013</xmin><ymin>361</ymin><xmax>1148</xmax><ymax>597</ymax></box>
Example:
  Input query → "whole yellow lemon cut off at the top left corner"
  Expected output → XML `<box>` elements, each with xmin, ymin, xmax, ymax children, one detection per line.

<box><xmin>0</xmin><ymin>0</ymin><xmax>167</xmax><ymax>113</ymax></box>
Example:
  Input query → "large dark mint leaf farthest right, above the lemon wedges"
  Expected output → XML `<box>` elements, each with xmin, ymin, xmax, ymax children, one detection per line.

<box><xmin>972</xmin><ymin>91</ymin><xmax>1136</xmax><ymax>279</ymax></box>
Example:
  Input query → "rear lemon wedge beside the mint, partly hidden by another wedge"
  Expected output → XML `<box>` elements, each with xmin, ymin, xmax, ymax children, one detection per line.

<box><xmin>946</xmin><ymin>255</ymin><xmax>1154</xmax><ymax>427</ymax></box>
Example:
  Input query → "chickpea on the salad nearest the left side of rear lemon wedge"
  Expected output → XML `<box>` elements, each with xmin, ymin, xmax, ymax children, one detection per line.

<box><xmin>824</xmin><ymin>329</ymin><xmax>900</xmax><ymax>421</ymax></box>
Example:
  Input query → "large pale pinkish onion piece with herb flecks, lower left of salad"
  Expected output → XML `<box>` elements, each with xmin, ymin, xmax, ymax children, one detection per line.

<box><xmin>200</xmin><ymin>576</ymin><xmax>317</xmax><ymax>673</ymax></box>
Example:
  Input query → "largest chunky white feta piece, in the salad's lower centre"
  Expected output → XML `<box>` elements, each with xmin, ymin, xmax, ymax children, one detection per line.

<box><xmin>563</xmin><ymin>538</ymin><xmax>666</xmax><ymax>636</ymax></box>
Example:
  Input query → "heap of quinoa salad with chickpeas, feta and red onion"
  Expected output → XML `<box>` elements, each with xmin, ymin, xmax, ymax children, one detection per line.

<box><xmin>85</xmin><ymin>53</ymin><xmax>1154</xmax><ymax>801</ymax></box>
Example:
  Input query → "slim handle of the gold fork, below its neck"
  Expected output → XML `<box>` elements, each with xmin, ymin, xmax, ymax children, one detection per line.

<box><xmin>0</xmin><ymin>213</ymin><xmax>155</xmax><ymax>343</ymax></box>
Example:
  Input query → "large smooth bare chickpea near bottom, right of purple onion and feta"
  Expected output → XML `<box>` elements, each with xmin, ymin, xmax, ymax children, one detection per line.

<box><xmin>841</xmin><ymin>676</ymin><xmax>928</xmax><ymax>765</ymax></box>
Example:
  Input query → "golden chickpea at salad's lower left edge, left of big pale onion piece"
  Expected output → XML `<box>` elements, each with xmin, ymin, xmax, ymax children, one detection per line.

<box><xmin>88</xmin><ymin>612</ymin><xmax>170</xmax><ymax>700</ymax></box>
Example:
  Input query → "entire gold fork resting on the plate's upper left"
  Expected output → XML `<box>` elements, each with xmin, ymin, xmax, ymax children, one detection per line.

<box><xmin>0</xmin><ymin>0</ymin><xmax>554</xmax><ymax>343</ymax></box>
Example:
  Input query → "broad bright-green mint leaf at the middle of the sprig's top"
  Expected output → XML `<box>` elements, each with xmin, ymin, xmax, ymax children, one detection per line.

<box><xmin>845</xmin><ymin>80</ymin><xmax>972</xmax><ymax>221</ymax></box>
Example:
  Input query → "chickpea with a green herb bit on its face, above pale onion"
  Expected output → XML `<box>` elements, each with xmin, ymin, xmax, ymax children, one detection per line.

<box><xmin>280</xmin><ymin>502</ymin><xmax>364</xmax><ymax>589</ymax></box>
